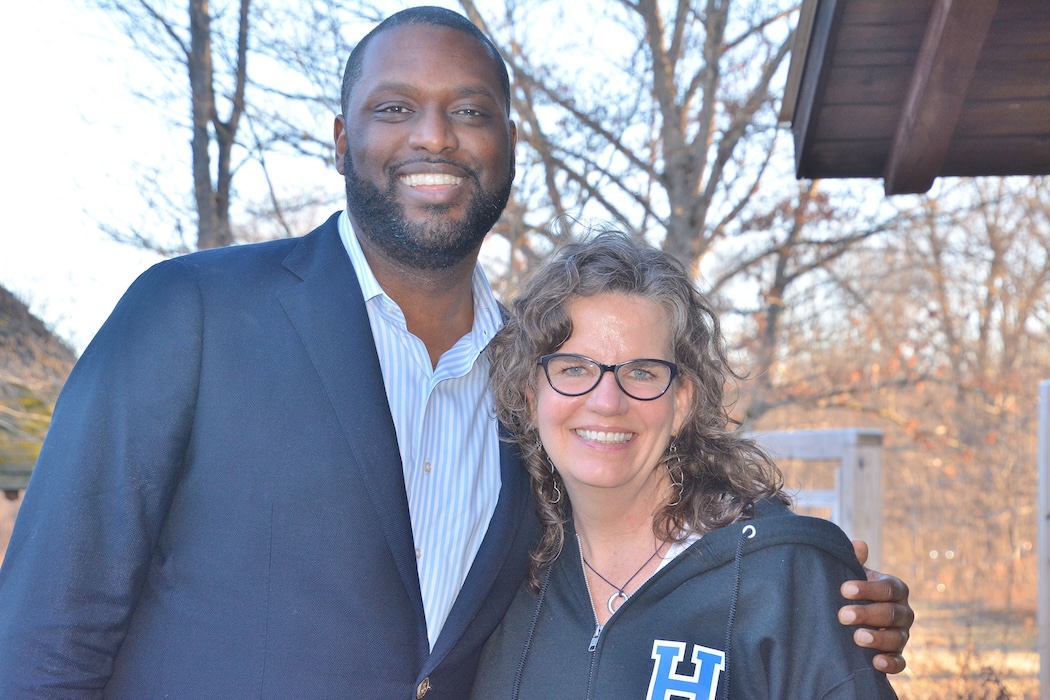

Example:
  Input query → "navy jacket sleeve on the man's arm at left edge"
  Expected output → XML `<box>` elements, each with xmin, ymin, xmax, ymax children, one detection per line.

<box><xmin>0</xmin><ymin>260</ymin><xmax>204</xmax><ymax>698</ymax></box>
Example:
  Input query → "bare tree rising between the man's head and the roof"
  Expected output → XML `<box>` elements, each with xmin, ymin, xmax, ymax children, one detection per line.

<box><xmin>460</xmin><ymin>0</ymin><xmax>796</xmax><ymax>264</ymax></box>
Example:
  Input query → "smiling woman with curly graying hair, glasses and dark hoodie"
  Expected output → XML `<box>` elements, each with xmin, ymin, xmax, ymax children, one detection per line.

<box><xmin>473</xmin><ymin>231</ymin><xmax>896</xmax><ymax>700</ymax></box>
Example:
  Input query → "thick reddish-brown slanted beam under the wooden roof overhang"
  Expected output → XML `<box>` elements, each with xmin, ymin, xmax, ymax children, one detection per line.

<box><xmin>883</xmin><ymin>0</ymin><xmax>999</xmax><ymax>194</ymax></box>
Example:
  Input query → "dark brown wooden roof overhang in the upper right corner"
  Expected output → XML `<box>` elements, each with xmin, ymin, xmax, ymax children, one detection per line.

<box><xmin>780</xmin><ymin>0</ymin><xmax>1050</xmax><ymax>194</ymax></box>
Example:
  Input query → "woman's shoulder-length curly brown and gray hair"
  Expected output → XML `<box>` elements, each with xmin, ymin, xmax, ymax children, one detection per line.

<box><xmin>488</xmin><ymin>230</ymin><xmax>789</xmax><ymax>588</ymax></box>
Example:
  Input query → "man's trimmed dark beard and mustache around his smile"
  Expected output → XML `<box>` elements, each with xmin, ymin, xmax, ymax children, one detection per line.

<box><xmin>343</xmin><ymin>152</ymin><xmax>515</xmax><ymax>270</ymax></box>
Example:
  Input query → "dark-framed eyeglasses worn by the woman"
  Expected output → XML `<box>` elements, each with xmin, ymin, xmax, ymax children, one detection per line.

<box><xmin>540</xmin><ymin>353</ymin><xmax>678</xmax><ymax>401</ymax></box>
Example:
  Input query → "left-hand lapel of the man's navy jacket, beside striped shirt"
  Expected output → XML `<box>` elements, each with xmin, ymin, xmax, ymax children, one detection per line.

<box><xmin>278</xmin><ymin>214</ymin><xmax>426</xmax><ymax>633</ymax></box>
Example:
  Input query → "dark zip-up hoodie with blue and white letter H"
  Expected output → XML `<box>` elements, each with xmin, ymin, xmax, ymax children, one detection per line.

<box><xmin>471</xmin><ymin>502</ymin><xmax>897</xmax><ymax>700</ymax></box>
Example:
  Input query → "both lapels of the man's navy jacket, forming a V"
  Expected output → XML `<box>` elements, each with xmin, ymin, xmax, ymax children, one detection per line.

<box><xmin>278</xmin><ymin>215</ymin><xmax>531</xmax><ymax>669</ymax></box>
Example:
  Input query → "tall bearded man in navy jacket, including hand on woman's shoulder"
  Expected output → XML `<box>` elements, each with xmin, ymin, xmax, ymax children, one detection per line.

<box><xmin>0</xmin><ymin>8</ymin><xmax>911</xmax><ymax>700</ymax></box>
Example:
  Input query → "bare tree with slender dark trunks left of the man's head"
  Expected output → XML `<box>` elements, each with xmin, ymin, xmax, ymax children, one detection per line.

<box><xmin>87</xmin><ymin>0</ymin><xmax>381</xmax><ymax>254</ymax></box>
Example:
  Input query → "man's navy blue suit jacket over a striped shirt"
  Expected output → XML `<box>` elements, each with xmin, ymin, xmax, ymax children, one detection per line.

<box><xmin>0</xmin><ymin>216</ymin><xmax>537</xmax><ymax>700</ymax></box>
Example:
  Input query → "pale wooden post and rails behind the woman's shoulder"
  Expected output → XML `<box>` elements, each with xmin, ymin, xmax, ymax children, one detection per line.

<box><xmin>754</xmin><ymin>428</ymin><xmax>882</xmax><ymax>569</ymax></box>
